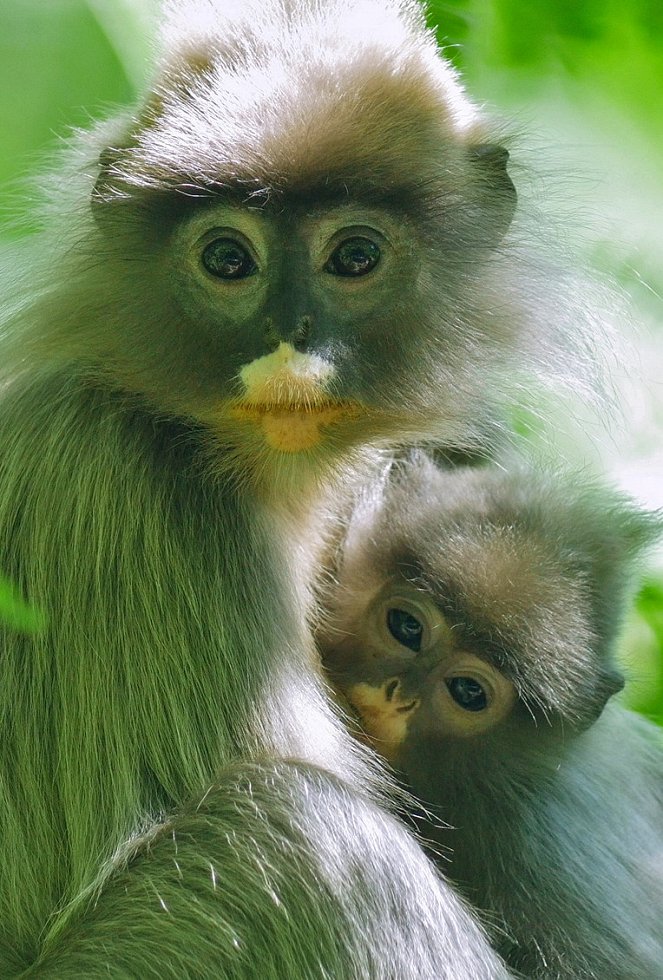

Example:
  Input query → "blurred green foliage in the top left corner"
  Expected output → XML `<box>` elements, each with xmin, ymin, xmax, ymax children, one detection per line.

<box><xmin>0</xmin><ymin>0</ymin><xmax>154</xmax><ymax>234</ymax></box>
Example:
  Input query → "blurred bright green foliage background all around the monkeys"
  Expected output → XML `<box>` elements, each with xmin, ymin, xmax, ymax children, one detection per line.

<box><xmin>0</xmin><ymin>0</ymin><xmax>663</xmax><ymax>722</ymax></box>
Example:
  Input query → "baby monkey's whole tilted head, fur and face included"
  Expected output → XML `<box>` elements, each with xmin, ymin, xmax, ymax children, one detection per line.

<box><xmin>320</xmin><ymin>457</ymin><xmax>657</xmax><ymax>782</ymax></box>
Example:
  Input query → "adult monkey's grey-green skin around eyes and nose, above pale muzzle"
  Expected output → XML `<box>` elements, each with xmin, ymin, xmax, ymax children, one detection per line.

<box><xmin>171</xmin><ymin>204</ymin><xmax>410</xmax><ymax>352</ymax></box>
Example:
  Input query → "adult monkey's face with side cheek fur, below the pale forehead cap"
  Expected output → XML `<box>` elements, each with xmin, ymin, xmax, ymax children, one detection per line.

<box><xmin>81</xmin><ymin>159</ymin><xmax>518</xmax><ymax>498</ymax></box>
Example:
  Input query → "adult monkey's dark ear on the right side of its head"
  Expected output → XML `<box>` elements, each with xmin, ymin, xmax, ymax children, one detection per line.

<box><xmin>467</xmin><ymin>143</ymin><xmax>518</xmax><ymax>248</ymax></box>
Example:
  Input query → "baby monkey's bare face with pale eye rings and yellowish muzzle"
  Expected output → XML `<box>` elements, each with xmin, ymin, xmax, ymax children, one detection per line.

<box><xmin>322</xmin><ymin>580</ymin><xmax>517</xmax><ymax>764</ymax></box>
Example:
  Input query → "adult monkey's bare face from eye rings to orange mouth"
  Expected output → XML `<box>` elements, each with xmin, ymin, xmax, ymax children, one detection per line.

<box><xmin>166</xmin><ymin>206</ymin><xmax>426</xmax><ymax>454</ymax></box>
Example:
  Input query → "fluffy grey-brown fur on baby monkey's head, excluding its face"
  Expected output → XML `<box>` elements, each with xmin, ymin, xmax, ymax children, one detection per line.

<box><xmin>325</xmin><ymin>455</ymin><xmax>658</xmax><ymax>725</ymax></box>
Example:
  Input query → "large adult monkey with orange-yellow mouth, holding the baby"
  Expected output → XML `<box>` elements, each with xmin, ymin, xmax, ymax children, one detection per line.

<box><xmin>0</xmin><ymin>0</ymin><xmax>588</xmax><ymax>980</ymax></box>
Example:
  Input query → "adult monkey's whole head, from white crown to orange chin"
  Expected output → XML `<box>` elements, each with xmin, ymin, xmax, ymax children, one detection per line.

<box><xmin>16</xmin><ymin>0</ymin><xmax>520</xmax><ymax>490</ymax></box>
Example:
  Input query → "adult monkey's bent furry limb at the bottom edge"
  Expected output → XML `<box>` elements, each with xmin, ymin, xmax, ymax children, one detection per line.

<box><xmin>23</xmin><ymin>763</ymin><xmax>508</xmax><ymax>980</ymax></box>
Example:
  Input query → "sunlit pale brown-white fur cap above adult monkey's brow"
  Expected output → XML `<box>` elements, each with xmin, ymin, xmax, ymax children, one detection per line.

<box><xmin>114</xmin><ymin>0</ymin><xmax>483</xmax><ymax>197</ymax></box>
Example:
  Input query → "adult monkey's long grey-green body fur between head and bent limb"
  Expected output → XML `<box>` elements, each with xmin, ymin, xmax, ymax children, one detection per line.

<box><xmin>0</xmin><ymin>375</ymin><xmax>368</xmax><ymax>956</ymax></box>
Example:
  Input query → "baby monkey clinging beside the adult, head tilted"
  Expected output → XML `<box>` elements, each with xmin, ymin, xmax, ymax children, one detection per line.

<box><xmin>320</xmin><ymin>456</ymin><xmax>663</xmax><ymax>980</ymax></box>
